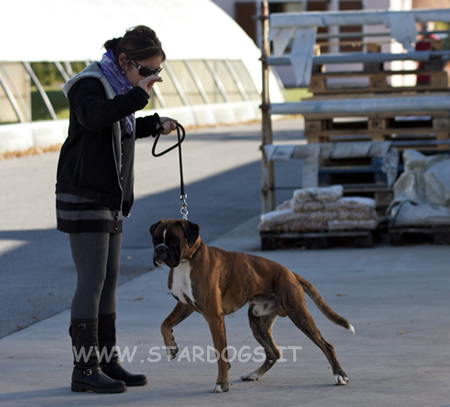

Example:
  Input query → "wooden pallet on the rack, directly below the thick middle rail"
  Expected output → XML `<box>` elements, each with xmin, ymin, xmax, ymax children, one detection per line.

<box><xmin>304</xmin><ymin>111</ymin><xmax>450</xmax><ymax>149</ymax></box>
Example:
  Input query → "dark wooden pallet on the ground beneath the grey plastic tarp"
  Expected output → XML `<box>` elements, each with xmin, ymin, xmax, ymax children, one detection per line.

<box><xmin>388</xmin><ymin>225</ymin><xmax>450</xmax><ymax>246</ymax></box>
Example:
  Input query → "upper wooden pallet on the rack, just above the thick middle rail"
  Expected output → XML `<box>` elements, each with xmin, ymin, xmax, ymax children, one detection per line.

<box><xmin>308</xmin><ymin>70</ymin><xmax>448</xmax><ymax>95</ymax></box>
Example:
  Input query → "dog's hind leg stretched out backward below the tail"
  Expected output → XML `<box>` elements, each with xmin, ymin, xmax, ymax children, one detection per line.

<box><xmin>281</xmin><ymin>284</ymin><xmax>349</xmax><ymax>385</ymax></box>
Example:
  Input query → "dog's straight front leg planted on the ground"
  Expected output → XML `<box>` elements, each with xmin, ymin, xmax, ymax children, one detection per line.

<box><xmin>205</xmin><ymin>310</ymin><xmax>230</xmax><ymax>393</ymax></box>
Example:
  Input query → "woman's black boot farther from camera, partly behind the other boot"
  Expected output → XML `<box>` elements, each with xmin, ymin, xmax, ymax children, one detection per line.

<box><xmin>98</xmin><ymin>313</ymin><xmax>147</xmax><ymax>387</ymax></box>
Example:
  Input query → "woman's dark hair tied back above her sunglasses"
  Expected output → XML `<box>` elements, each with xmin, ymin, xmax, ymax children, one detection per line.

<box><xmin>103</xmin><ymin>25</ymin><xmax>166</xmax><ymax>61</ymax></box>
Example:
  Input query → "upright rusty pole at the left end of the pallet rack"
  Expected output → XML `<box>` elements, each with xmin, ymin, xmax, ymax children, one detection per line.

<box><xmin>259</xmin><ymin>0</ymin><xmax>275</xmax><ymax>213</ymax></box>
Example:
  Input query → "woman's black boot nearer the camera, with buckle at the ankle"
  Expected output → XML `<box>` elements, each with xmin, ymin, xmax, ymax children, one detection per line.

<box><xmin>69</xmin><ymin>318</ymin><xmax>127</xmax><ymax>393</ymax></box>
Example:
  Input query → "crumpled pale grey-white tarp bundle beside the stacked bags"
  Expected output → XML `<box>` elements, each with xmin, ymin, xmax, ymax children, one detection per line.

<box><xmin>387</xmin><ymin>150</ymin><xmax>450</xmax><ymax>226</ymax></box>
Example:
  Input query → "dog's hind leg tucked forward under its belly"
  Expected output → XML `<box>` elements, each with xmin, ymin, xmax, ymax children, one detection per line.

<box><xmin>241</xmin><ymin>305</ymin><xmax>281</xmax><ymax>380</ymax></box>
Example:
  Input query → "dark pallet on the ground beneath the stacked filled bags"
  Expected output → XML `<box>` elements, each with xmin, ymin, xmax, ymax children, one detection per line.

<box><xmin>260</xmin><ymin>230</ymin><xmax>378</xmax><ymax>250</ymax></box>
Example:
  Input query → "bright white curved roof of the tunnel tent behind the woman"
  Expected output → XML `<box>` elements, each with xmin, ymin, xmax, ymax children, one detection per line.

<box><xmin>0</xmin><ymin>0</ymin><xmax>259</xmax><ymax>61</ymax></box>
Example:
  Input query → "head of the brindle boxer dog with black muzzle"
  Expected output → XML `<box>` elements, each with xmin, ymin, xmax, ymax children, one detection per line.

<box><xmin>150</xmin><ymin>219</ymin><xmax>200</xmax><ymax>268</ymax></box>
